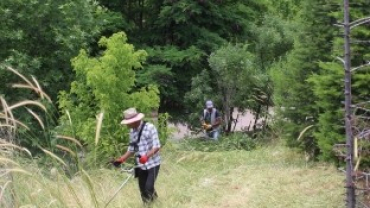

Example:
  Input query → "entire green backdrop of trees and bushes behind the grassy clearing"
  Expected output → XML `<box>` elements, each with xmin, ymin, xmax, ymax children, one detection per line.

<box><xmin>0</xmin><ymin>0</ymin><xmax>370</xmax><ymax>167</ymax></box>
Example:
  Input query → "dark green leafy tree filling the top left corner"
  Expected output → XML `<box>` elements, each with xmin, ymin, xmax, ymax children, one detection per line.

<box><xmin>0</xmin><ymin>0</ymin><xmax>103</xmax><ymax>101</ymax></box>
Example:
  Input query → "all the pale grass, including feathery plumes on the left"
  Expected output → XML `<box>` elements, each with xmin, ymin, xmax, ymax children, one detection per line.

<box><xmin>0</xmin><ymin>68</ymin><xmax>344</xmax><ymax>208</ymax></box>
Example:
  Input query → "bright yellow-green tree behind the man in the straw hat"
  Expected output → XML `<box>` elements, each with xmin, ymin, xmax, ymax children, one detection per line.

<box><xmin>59</xmin><ymin>32</ymin><xmax>159</xmax><ymax>159</ymax></box>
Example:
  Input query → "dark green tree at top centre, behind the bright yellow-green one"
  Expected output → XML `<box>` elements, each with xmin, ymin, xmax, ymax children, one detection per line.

<box><xmin>97</xmin><ymin>0</ymin><xmax>265</xmax><ymax>111</ymax></box>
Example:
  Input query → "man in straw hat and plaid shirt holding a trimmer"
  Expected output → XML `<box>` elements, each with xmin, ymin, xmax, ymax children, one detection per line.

<box><xmin>113</xmin><ymin>108</ymin><xmax>161</xmax><ymax>204</ymax></box>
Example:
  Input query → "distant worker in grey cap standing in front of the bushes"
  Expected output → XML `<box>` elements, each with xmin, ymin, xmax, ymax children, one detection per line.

<box><xmin>200</xmin><ymin>100</ymin><xmax>221</xmax><ymax>141</ymax></box>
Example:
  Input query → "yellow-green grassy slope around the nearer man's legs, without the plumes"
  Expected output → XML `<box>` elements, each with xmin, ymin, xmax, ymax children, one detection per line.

<box><xmin>0</xmin><ymin>141</ymin><xmax>344</xmax><ymax>208</ymax></box>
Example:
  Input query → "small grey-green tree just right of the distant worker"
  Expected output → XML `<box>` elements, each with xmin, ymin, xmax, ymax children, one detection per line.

<box><xmin>209</xmin><ymin>44</ymin><xmax>260</xmax><ymax>132</ymax></box>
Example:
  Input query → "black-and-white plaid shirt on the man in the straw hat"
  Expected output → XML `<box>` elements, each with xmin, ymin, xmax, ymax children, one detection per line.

<box><xmin>128</xmin><ymin>122</ymin><xmax>161</xmax><ymax>170</ymax></box>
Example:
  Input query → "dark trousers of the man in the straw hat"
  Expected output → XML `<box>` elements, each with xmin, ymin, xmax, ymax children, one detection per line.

<box><xmin>137</xmin><ymin>165</ymin><xmax>160</xmax><ymax>204</ymax></box>
